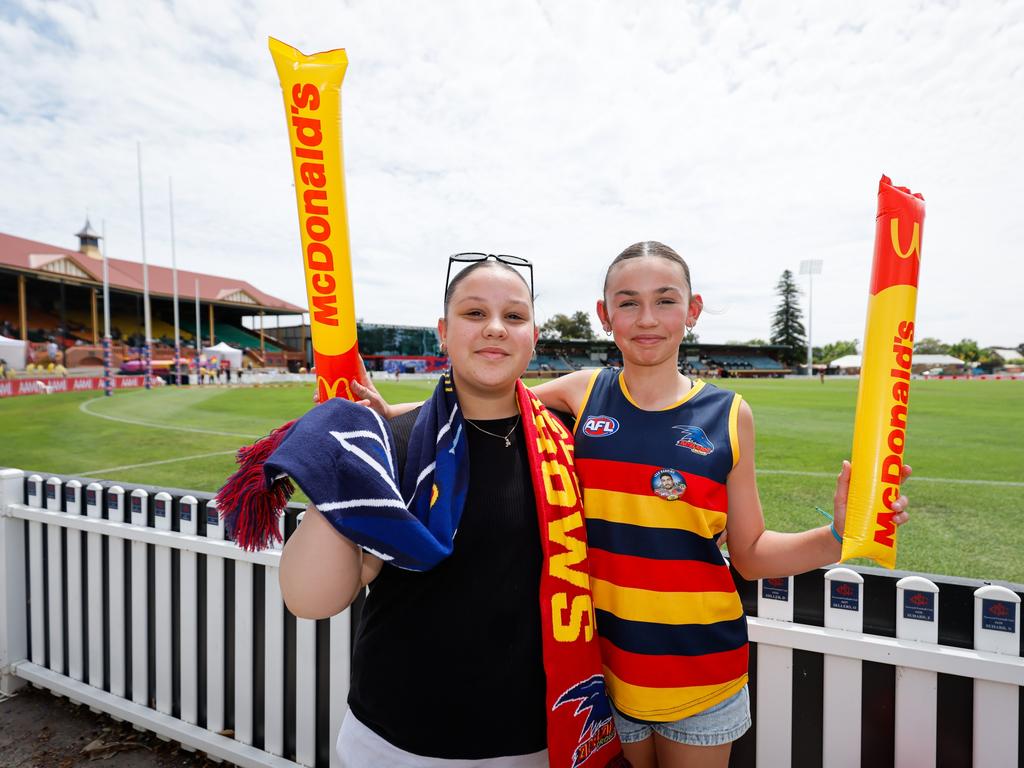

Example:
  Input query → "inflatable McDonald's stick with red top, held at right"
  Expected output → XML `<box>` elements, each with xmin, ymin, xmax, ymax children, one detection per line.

<box><xmin>843</xmin><ymin>176</ymin><xmax>925</xmax><ymax>568</ymax></box>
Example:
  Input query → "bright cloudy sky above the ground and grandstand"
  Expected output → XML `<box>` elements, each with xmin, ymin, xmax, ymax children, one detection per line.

<box><xmin>0</xmin><ymin>0</ymin><xmax>1024</xmax><ymax>346</ymax></box>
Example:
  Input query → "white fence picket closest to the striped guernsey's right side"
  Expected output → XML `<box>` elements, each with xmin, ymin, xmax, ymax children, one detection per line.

<box><xmin>757</xmin><ymin>577</ymin><xmax>793</xmax><ymax>765</ymax></box>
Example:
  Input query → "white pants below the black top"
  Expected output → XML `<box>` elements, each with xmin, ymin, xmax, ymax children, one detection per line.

<box><xmin>335</xmin><ymin>712</ymin><xmax>548</xmax><ymax>768</ymax></box>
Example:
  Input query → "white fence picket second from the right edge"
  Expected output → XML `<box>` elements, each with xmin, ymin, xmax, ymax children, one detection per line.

<box><xmin>896</xmin><ymin>577</ymin><xmax>939</xmax><ymax>768</ymax></box>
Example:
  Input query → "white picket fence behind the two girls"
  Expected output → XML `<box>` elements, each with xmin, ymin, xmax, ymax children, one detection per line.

<box><xmin>0</xmin><ymin>469</ymin><xmax>1024</xmax><ymax>768</ymax></box>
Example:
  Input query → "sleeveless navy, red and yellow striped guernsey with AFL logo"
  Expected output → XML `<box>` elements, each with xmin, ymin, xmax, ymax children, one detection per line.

<box><xmin>575</xmin><ymin>369</ymin><xmax>748</xmax><ymax>722</ymax></box>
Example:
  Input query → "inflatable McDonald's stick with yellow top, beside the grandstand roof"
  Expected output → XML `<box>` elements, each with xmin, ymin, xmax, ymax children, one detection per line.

<box><xmin>270</xmin><ymin>38</ymin><xmax>361</xmax><ymax>402</ymax></box>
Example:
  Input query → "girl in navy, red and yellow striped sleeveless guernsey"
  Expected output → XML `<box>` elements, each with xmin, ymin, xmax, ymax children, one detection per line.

<box><xmin>535</xmin><ymin>242</ymin><xmax>909</xmax><ymax>768</ymax></box>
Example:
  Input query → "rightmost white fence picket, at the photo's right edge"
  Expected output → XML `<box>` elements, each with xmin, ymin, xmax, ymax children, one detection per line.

<box><xmin>974</xmin><ymin>585</ymin><xmax>1021</xmax><ymax>768</ymax></box>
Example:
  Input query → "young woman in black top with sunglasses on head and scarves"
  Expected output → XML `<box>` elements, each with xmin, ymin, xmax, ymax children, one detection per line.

<box><xmin>267</xmin><ymin>254</ymin><xmax>621</xmax><ymax>768</ymax></box>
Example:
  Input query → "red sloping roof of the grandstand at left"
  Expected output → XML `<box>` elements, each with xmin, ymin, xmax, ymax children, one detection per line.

<box><xmin>0</xmin><ymin>232</ymin><xmax>306</xmax><ymax>314</ymax></box>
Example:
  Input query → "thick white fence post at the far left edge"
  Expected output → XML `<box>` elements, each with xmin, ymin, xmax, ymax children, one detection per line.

<box><xmin>0</xmin><ymin>469</ymin><xmax>29</xmax><ymax>695</ymax></box>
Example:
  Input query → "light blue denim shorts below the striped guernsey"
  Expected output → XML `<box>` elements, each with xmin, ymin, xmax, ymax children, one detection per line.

<box><xmin>613</xmin><ymin>685</ymin><xmax>751</xmax><ymax>746</ymax></box>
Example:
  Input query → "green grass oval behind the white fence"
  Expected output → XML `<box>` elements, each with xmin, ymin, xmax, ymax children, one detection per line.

<box><xmin>0</xmin><ymin>379</ymin><xmax>1024</xmax><ymax>583</ymax></box>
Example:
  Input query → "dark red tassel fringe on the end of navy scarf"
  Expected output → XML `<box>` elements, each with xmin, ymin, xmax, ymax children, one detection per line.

<box><xmin>216</xmin><ymin>421</ymin><xmax>295</xmax><ymax>552</ymax></box>
